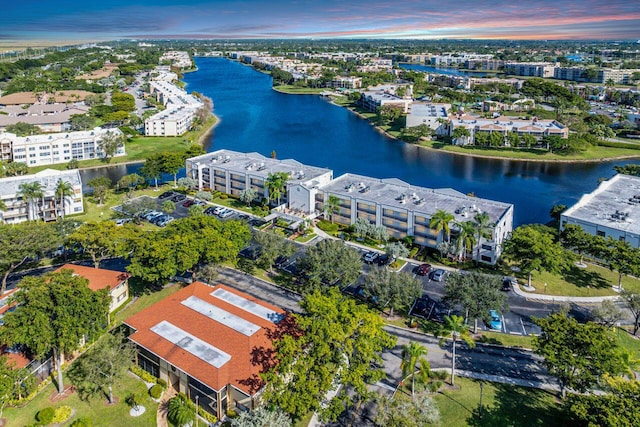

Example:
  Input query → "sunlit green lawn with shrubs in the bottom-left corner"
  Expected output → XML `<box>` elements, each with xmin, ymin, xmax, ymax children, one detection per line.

<box><xmin>3</xmin><ymin>374</ymin><xmax>158</xmax><ymax>427</ymax></box>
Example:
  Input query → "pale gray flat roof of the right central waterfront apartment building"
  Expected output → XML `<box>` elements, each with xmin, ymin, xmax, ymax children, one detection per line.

<box><xmin>322</xmin><ymin>173</ymin><xmax>513</xmax><ymax>222</ymax></box>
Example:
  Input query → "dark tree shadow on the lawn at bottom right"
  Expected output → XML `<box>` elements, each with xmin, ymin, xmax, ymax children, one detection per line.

<box><xmin>466</xmin><ymin>383</ymin><xmax>569</xmax><ymax>427</ymax></box>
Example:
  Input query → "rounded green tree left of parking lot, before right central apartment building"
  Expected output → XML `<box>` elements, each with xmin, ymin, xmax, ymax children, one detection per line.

<box><xmin>298</xmin><ymin>239</ymin><xmax>362</xmax><ymax>287</ymax></box>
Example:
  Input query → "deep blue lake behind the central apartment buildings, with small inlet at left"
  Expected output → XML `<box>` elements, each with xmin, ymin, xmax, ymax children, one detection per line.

<box><xmin>83</xmin><ymin>58</ymin><xmax>640</xmax><ymax>224</ymax></box>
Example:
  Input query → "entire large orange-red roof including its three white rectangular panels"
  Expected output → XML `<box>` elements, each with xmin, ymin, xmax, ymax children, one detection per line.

<box><xmin>125</xmin><ymin>282</ymin><xmax>284</xmax><ymax>395</ymax></box>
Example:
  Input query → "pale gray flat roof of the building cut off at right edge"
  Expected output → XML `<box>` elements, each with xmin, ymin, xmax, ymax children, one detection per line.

<box><xmin>562</xmin><ymin>174</ymin><xmax>640</xmax><ymax>234</ymax></box>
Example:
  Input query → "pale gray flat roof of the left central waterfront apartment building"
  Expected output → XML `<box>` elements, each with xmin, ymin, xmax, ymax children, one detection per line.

<box><xmin>188</xmin><ymin>150</ymin><xmax>331</xmax><ymax>183</ymax></box>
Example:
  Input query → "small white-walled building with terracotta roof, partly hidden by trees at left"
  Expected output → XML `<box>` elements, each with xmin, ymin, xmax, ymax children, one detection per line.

<box><xmin>57</xmin><ymin>264</ymin><xmax>131</xmax><ymax>313</ymax></box>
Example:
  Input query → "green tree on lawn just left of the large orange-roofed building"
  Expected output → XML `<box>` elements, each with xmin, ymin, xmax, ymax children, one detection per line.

<box><xmin>69</xmin><ymin>333</ymin><xmax>136</xmax><ymax>403</ymax></box>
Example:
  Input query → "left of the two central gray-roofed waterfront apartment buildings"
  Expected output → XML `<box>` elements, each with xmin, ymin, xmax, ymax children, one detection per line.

<box><xmin>186</xmin><ymin>150</ymin><xmax>333</xmax><ymax>214</ymax></box>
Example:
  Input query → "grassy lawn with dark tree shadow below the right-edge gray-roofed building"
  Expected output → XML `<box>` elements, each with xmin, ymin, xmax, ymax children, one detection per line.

<box><xmin>519</xmin><ymin>264</ymin><xmax>640</xmax><ymax>297</ymax></box>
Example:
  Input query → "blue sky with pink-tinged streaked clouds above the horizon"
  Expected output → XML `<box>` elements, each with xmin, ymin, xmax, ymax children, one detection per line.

<box><xmin>0</xmin><ymin>0</ymin><xmax>640</xmax><ymax>40</ymax></box>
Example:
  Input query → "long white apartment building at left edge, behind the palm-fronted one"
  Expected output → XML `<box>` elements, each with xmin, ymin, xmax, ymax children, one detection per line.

<box><xmin>0</xmin><ymin>128</ymin><xmax>127</xmax><ymax>167</ymax></box>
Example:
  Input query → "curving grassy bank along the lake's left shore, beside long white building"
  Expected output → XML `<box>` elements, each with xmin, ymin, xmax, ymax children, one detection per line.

<box><xmin>29</xmin><ymin>116</ymin><xmax>217</xmax><ymax>173</ymax></box>
